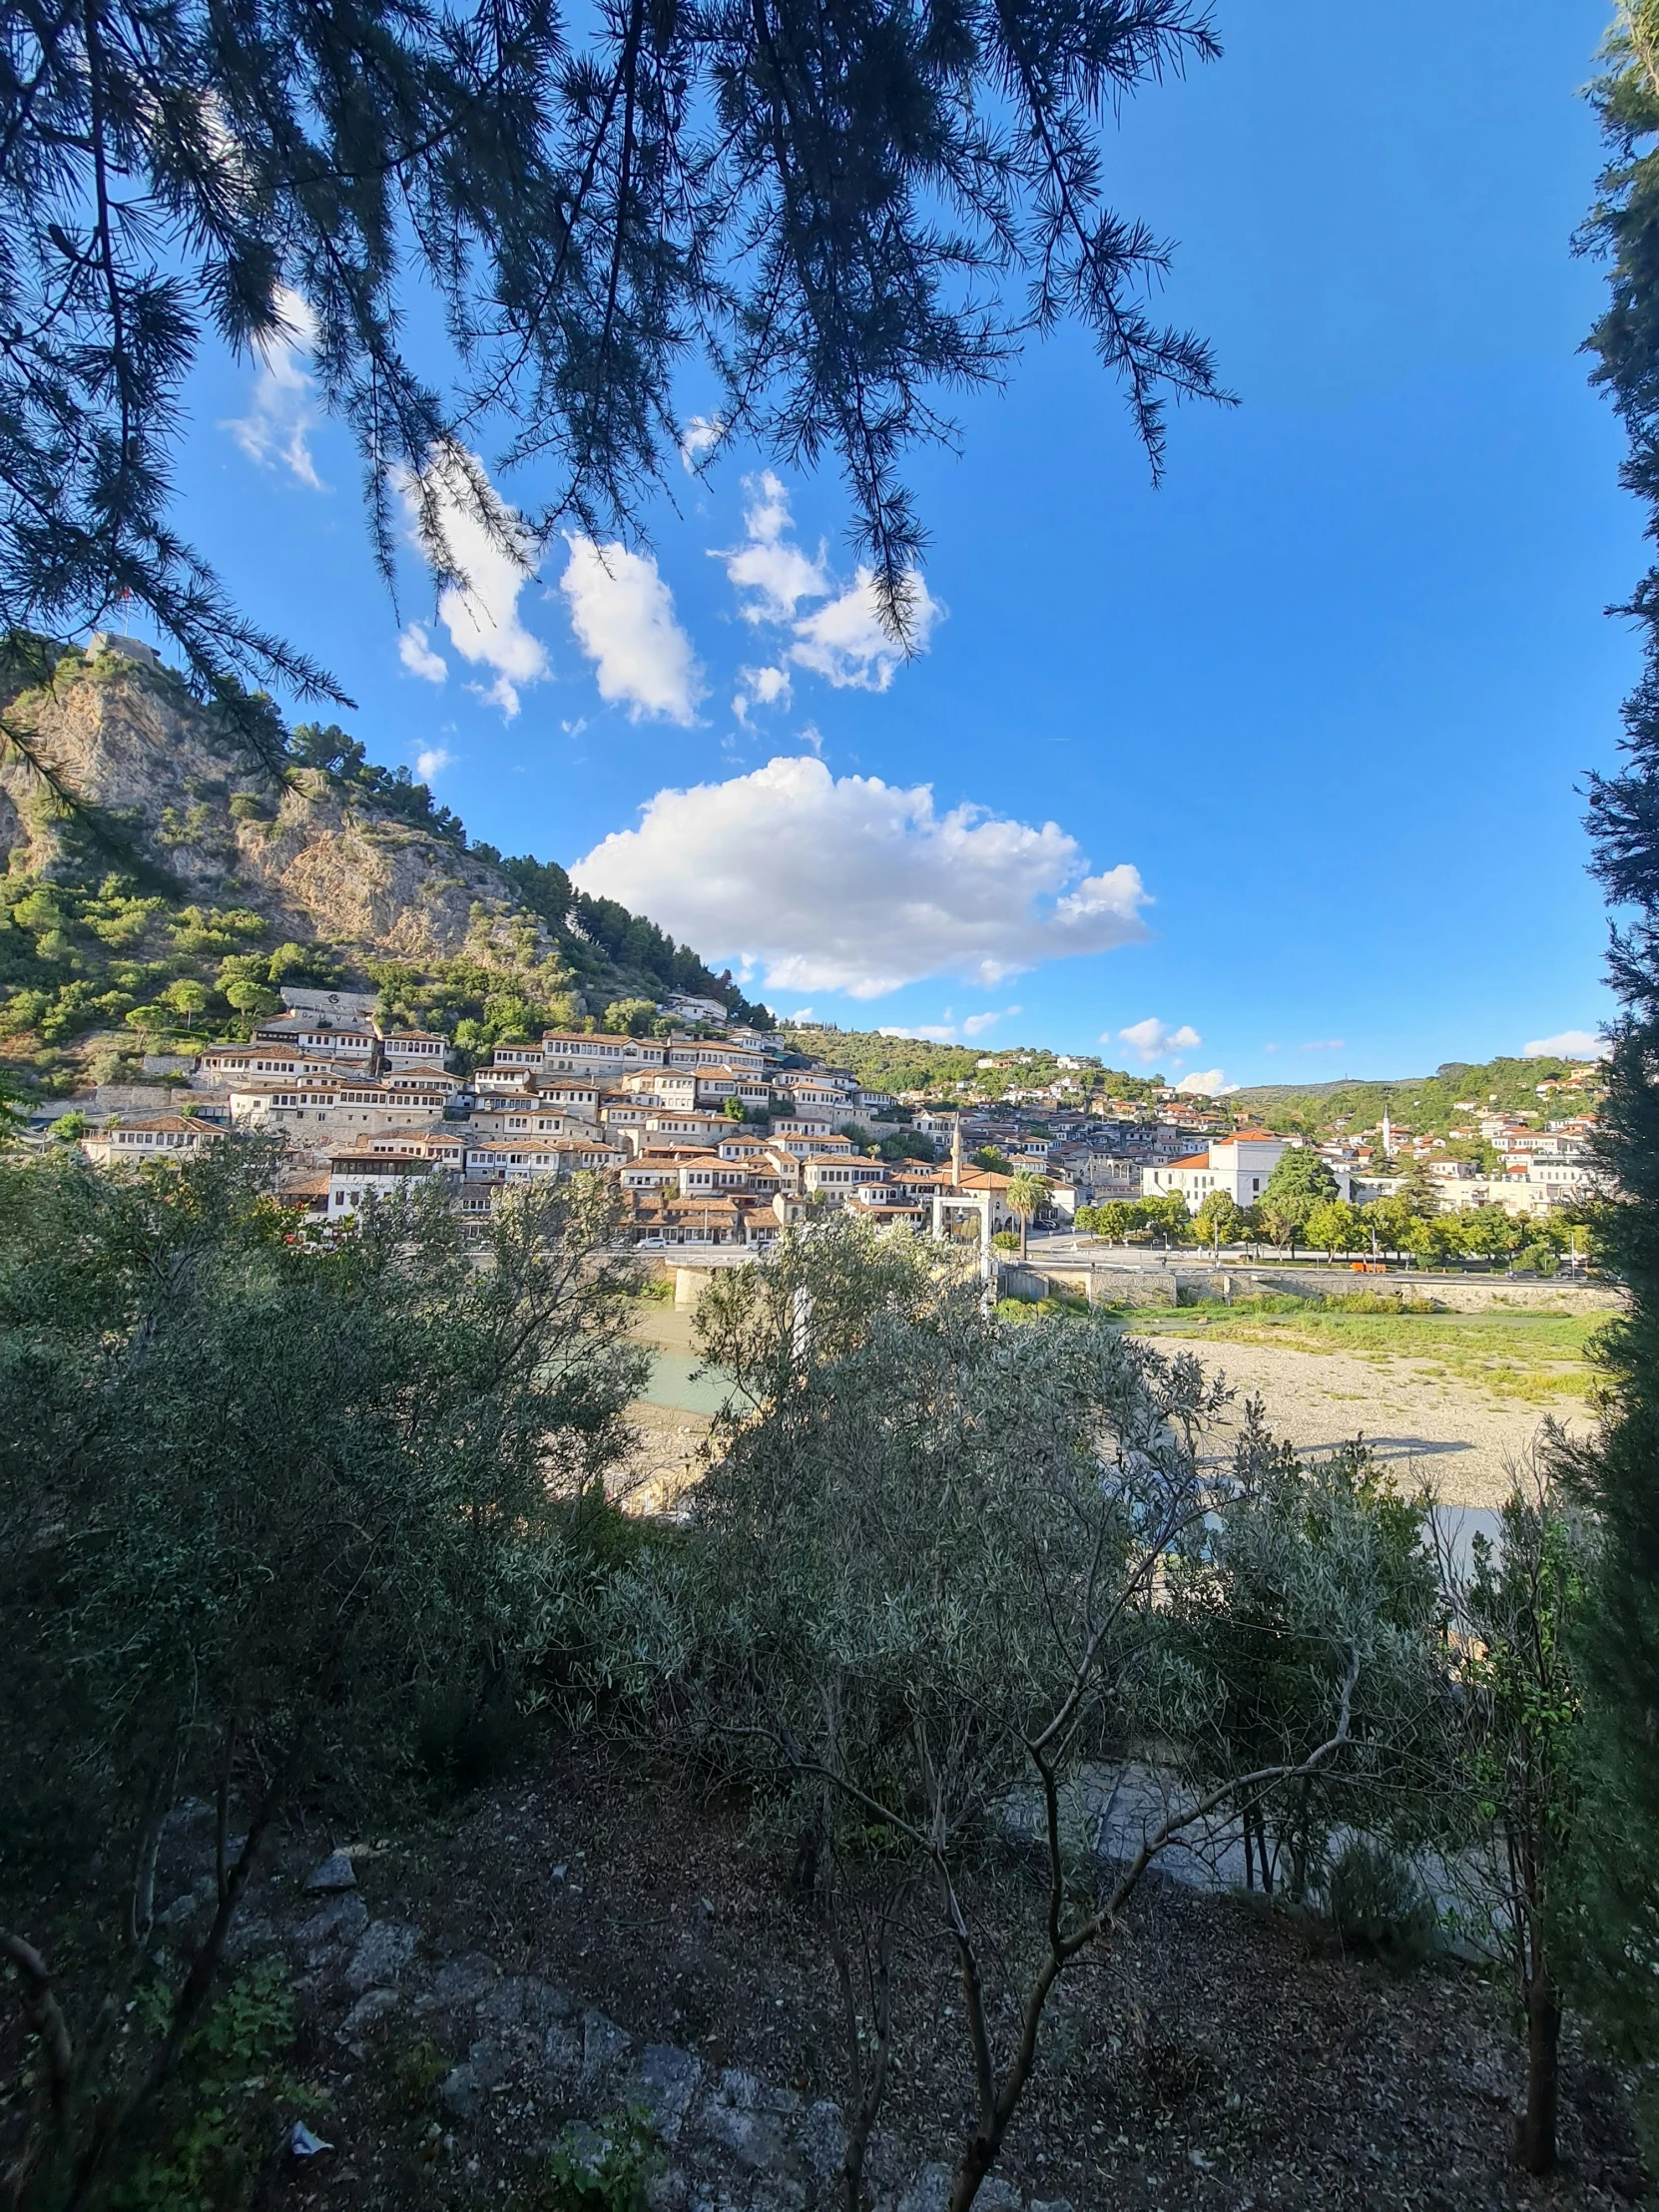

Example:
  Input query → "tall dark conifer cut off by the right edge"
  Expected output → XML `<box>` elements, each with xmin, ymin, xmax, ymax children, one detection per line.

<box><xmin>1577</xmin><ymin>0</ymin><xmax>1659</xmax><ymax>2096</ymax></box>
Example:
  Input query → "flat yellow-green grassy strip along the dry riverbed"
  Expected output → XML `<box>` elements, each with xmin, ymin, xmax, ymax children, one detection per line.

<box><xmin>1133</xmin><ymin>1299</ymin><xmax>1606</xmax><ymax>1404</ymax></box>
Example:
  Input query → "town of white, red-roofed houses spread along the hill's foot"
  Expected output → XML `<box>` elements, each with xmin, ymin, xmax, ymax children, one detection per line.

<box><xmin>35</xmin><ymin>989</ymin><xmax>1597</xmax><ymax>1248</ymax></box>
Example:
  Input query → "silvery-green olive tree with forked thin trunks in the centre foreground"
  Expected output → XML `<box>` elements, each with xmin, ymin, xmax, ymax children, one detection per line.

<box><xmin>679</xmin><ymin>1221</ymin><xmax>1374</xmax><ymax>2212</ymax></box>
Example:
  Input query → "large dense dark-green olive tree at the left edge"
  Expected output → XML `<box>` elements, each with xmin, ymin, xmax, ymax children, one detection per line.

<box><xmin>0</xmin><ymin>1139</ymin><xmax>642</xmax><ymax>2205</ymax></box>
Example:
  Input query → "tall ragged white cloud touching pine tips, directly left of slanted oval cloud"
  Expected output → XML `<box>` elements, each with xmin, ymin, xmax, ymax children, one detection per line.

<box><xmin>398</xmin><ymin>444</ymin><xmax>549</xmax><ymax>721</ymax></box>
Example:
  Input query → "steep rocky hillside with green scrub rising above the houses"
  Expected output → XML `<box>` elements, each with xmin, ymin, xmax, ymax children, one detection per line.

<box><xmin>0</xmin><ymin>648</ymin><xmax>766</xmax><ymax>1095</ymax></box>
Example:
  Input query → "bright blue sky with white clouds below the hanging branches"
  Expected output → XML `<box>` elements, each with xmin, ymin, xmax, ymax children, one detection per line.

<box><xmin>166</xmin><ymin>0</ymin><xmax>1643</xmax><ymax>1082</ymax></box>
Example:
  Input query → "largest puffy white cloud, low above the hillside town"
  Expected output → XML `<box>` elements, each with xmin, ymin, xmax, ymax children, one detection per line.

<box><xmin>571</xmin><ymin>757</ymin><xmax>1146</xmax><ymax>997</ymax></box>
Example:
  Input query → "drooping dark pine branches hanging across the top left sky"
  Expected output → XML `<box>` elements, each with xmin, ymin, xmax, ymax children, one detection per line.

<box><xmin>0</xmin><ymin>0</ymin><xmax>1219</xmax><ymax>693</ymax></box>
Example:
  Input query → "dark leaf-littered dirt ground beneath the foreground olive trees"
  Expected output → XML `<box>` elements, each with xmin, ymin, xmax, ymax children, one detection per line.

<box><xmin>273</xmin><ymin>1745</ymin><xmax>1641</xmax><ymax>2212</ymax></box>
